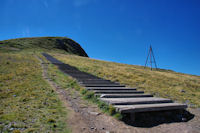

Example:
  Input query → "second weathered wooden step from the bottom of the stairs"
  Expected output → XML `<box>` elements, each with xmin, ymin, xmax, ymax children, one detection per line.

<box><xmin>100</xmin><ymin>97</ymin><xmax>172</xmax><ymax>105</ymax></box>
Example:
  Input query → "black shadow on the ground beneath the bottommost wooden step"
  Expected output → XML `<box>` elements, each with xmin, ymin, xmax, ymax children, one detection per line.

<box><xmin>122</xmin><ymin>110</ymin><xmax>195</xmax><ymax>128</ymax></box>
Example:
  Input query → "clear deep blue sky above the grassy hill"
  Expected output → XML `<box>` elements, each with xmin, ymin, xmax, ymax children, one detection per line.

<box><xmin>0</xmin><ymin>0</ymin><xmax>200</xmax><ymax>75</ymax></box>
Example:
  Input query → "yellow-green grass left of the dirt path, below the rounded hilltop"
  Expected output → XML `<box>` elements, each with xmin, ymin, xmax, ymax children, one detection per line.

<box><xmin>0</xmin><ymin>53</ymin><xmax>68</xmax><ymax>133</ymax></box>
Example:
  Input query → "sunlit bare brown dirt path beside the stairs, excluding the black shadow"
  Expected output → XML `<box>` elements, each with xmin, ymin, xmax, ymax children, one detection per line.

<box><xmin>37</xmin><ymin>57</ymin><xmax>200</xmax><ymax>133</ymax></box>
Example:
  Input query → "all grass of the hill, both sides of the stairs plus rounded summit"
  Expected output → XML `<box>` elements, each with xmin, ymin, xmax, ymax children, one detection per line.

<box><xmin>0</xmin><ymin>37</ymin><xmax>200</xmax><ymax>133</ymax></box>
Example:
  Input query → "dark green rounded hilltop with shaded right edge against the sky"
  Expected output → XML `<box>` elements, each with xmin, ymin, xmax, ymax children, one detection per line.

<box><xmin>0</xmin><ymin>37</ymin><xmax>88</xmax><ymax>57</ymax></box>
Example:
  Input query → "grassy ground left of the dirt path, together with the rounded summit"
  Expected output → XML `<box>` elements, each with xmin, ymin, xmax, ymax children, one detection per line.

<box><xmin>0</xmin><ymin>37</ymin><xmax>88</xmax><ymax>133</ymax></box>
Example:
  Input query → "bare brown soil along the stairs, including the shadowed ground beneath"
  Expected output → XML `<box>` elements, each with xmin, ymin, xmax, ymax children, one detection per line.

<box><xmin>37</xmin><ymin>57</ymin><xmax>200</xmax><ymax>133</ymax></box>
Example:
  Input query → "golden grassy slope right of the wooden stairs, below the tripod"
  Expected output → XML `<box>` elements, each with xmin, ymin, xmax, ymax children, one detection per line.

<box><xmin>52</xmin><ymin>54</ymin><xmax>200</xmax><ymax>107</ymax></box>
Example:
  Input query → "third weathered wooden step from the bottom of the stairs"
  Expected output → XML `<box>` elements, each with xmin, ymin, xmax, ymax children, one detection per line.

<box><xmin>97</xmin><ymin>94</ymin><xmax>153</xmax><ymax>98</ymax></box>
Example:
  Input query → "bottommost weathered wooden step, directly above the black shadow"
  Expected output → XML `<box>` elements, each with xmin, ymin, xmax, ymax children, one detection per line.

<box><xmin>114</xmin><ymin>103</ymin><xmax>187</xmax><ymax>113</ymax></box>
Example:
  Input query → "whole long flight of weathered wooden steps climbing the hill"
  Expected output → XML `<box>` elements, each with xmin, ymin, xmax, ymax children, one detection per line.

<box><xmin>43</xmin><ymin>53</ymin><xmax>187</xmax><ymax>120</ymax></box>
